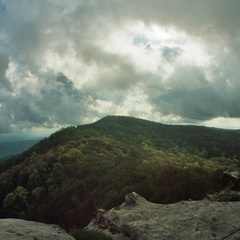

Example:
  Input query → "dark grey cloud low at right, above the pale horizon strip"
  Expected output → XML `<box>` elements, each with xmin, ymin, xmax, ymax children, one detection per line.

<box><xmin>146</xmin><ymin>66</ymin><xmax>240</xmax><ymax>120</ymax></box>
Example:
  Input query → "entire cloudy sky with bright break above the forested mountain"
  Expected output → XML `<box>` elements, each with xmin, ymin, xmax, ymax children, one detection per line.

<box><xmin>0</xmin><ymin>0</ymin><xmax>240</xmax><ymax>133</ymax></box>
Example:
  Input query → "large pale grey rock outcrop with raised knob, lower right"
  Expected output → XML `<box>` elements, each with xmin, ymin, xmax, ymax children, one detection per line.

<box><xmin>87</xmin><ymin>193</ymin><xmax>240</xmax><ymax>240</ymax></box>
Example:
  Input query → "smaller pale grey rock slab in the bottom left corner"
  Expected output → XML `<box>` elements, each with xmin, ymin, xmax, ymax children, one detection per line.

<box><xmin>0</xmin><ymin>218</ymin><xmax>74</xmax><ymax>240</ymax></box>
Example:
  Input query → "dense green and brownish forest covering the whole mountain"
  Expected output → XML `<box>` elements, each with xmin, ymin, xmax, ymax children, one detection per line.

<box><xmin>0</xmin><ymin>116</ymin><xmax>240</xmax><ymax>229</ymax></box>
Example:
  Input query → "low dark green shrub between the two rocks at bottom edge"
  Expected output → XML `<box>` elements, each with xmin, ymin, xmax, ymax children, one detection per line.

<box><xmin>72</xmin><ymin>230</ymin><xmax>112</xmax><ymax>240</ymax></box>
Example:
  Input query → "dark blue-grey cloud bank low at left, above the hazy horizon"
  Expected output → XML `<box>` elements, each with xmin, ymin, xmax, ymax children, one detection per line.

<box><xmin>0</xmin><ymin>73</ymin><xmax>95</xmax><ymax>132</ymax></box>
